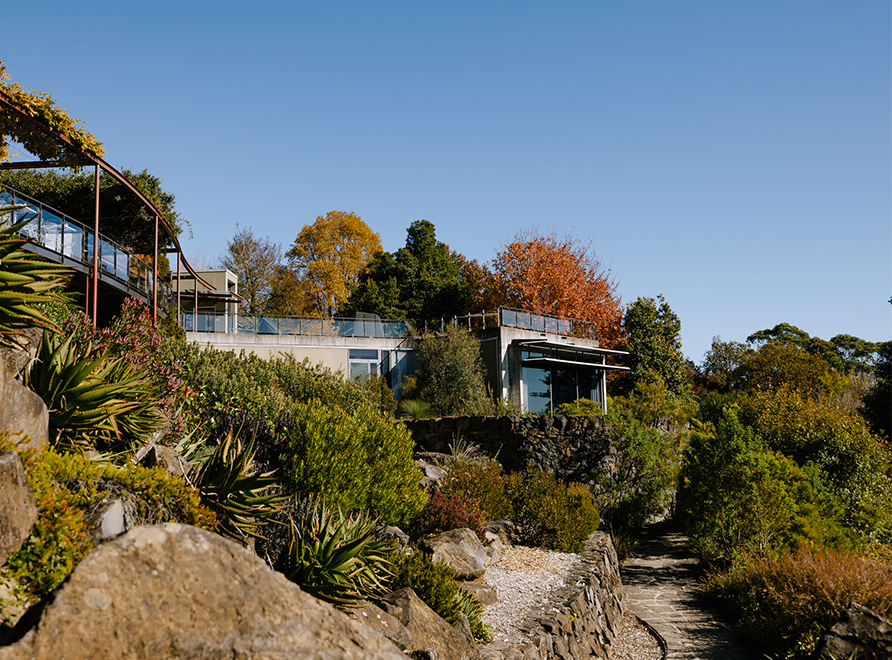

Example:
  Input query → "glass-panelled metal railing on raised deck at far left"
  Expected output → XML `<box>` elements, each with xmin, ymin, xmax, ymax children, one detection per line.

<box><xmin>0</xmin><ymin>186</ymin><xmax>175</xmax><ymax>309</ymax></box>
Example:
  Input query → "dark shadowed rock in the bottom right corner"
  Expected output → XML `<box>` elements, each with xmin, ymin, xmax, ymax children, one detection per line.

<box><xmin>815</xmin><ymin>603</ymin><xmax>892</xmax><ymax>660</ymax></box>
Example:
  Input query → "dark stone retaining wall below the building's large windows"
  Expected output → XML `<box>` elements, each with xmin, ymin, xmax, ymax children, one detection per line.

<box><xmin>405</xmin><ymin>415</ymin><xmax>611</xmax><ymax>483</ymax></box>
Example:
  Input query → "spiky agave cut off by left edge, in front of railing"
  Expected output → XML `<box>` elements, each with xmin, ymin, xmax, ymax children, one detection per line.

<box><xmin>0</xmin><ymin>214</ymin><xmax>71</xmax><ymax>346</ymax></box>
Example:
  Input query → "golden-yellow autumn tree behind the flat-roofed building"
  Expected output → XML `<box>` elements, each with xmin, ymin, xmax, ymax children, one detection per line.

<box><xmin>286</xmin><ymin>211</ymin><xmax>381</xmax><ymax>316</ymax></box>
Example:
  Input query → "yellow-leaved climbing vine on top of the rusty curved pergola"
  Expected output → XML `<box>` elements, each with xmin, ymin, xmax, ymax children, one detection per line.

<box><xmin>0</xmin><ymin>60</ymin><xmax>105</xmax><ymax>168</ymax></box>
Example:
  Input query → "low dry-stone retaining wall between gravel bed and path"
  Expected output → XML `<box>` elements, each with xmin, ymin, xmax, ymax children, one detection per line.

<box><xmin>481</xmin><ymin>532</ymin><xmax>623</xmax><ymax>660</ymax></box>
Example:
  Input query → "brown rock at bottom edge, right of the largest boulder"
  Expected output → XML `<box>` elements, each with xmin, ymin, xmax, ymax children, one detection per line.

<box><xmin>384</xmin><ymin>588</ymin><xmax>480</xmax><ymax>660</ymax></box>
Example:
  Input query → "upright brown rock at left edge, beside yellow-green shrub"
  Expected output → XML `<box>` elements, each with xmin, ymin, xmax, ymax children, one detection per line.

<box><xmin>0</xmin><ymin>450</ymin><xmax>37</xmax><ymax>566</ymax></box>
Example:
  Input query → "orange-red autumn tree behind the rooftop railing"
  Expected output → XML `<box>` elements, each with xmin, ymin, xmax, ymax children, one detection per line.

<box><xmin>480</xmin><ymin>231</ymin><xmax>622</xmax><ymax>347</ymax></box>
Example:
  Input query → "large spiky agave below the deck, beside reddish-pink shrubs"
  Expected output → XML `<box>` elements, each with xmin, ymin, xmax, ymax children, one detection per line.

<box><xmin>25</xmin><ymin>331</ymin><xmax>158</xmax><ymax>447</ymax></box>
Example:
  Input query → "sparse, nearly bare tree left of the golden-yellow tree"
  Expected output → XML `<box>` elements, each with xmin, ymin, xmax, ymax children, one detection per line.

<box><xmin>220</xmin><ymin>225</ymin><xmax>282</xmax><ymax>314</ymax></box>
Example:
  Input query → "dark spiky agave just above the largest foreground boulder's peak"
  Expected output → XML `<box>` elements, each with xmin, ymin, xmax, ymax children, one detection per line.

<box><xmin>191</xmin><ymin>433</ymin><xmax>288</xmax><ymax>543</ymax></box>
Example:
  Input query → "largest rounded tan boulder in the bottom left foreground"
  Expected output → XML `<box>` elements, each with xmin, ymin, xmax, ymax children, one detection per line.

<box><xmin>0</xmin><ymin>524</ymin><xmax>405</xmax><ymax>660</ymax></box>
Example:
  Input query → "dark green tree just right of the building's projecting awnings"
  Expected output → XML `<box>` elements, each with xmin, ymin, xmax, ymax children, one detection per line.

<box><xmin>623</xmin><ymin>295</ymin><xmax>690</xmax><ymax>396</ymax></box>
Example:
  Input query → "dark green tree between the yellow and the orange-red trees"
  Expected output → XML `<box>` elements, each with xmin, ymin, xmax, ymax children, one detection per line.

<box><xmin>340</xmin><ymin>220</ymin><xmax>471</xmax><ymax>322</ymax></box>
